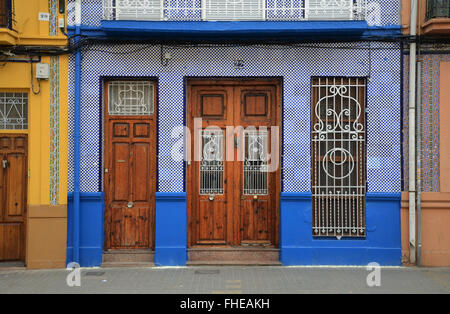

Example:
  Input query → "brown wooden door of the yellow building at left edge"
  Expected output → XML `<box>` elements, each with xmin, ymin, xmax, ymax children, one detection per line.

<box><xmin>0</xmin><ymin>134</ymin><xmax>28</xmax><ymax>261</ymax></box>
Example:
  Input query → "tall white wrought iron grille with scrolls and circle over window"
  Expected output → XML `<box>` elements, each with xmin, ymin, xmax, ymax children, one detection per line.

<box><xmin>312</xmin><ymin>78</ymin><xmax>366</xmax><ymax>238</ymax></box>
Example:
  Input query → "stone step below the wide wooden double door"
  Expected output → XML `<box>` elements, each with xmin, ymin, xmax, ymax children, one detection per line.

<box><xmin>188</xmin><ymin>248</ymin><xmax>280</xmax><ymax>265</ymax></box>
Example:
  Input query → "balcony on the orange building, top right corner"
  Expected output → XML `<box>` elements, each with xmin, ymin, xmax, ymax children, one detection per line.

<box><xmin>422</xmin><ymin>0</ymin><xmax>450</xmax><ymax>35</ymax></box>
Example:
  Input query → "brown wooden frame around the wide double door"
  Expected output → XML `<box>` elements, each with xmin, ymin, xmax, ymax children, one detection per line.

<box><xmin>184</xmin><ymin>76</ymin><xmax>283</xmax><ymax>248</ymax></box>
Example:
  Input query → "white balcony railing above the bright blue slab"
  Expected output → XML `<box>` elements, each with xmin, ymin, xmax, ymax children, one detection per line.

<box><xmin>103</xmin><ymin>0</ymin><xmax>367</xmax><ymax>21</ymax></box>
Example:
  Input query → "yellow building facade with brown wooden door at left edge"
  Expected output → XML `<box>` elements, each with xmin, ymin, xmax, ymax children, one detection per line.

<box><xmin>0</xmin><ymin>0</ymin><xmax>68</xmax><ymax>269</ymax></box>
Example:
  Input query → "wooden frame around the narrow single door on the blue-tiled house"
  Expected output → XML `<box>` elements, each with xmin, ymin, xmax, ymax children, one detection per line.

<box><xmin>101</xmin><ymin>77</ymin><xmax>158</xmax><ymax>250</ymax></box>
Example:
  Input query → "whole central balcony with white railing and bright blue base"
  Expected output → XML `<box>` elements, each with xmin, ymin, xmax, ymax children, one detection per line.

<box><xmin>80</xmin><ymin>0</ymin><xmax>400</xmax><ymax>43</ymax></box>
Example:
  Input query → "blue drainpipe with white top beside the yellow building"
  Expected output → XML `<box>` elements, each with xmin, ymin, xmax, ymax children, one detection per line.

<box><xmin>73</xmin><ymin>0</ymin><xmax>81</xmax><ymax>264</ymax></box>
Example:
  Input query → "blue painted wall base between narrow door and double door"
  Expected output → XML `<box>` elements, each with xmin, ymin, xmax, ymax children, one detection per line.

<box><xmin>155</xmin><ymin>192</ymin><xmax>187</xmax><ymax>266</ymax></box>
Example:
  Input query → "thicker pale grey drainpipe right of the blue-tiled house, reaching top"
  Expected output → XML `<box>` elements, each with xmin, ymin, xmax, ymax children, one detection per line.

<box><xmin>408</xmin><ymin>0</ymin><xmax>417</xmax><ymax>264</ymax></box>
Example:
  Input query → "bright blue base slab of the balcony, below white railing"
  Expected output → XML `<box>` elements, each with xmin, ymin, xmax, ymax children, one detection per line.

<box><xmin>68</xmin><ymin>20</ymin><xmax>402</xmax><ymax>42</ymax></box>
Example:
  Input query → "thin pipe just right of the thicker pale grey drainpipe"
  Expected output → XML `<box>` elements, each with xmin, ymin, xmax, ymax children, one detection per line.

<box><xmin>416</xmin><ymin>61</ymin><xmax>422</xmax><ymax>266</ymax></box>
